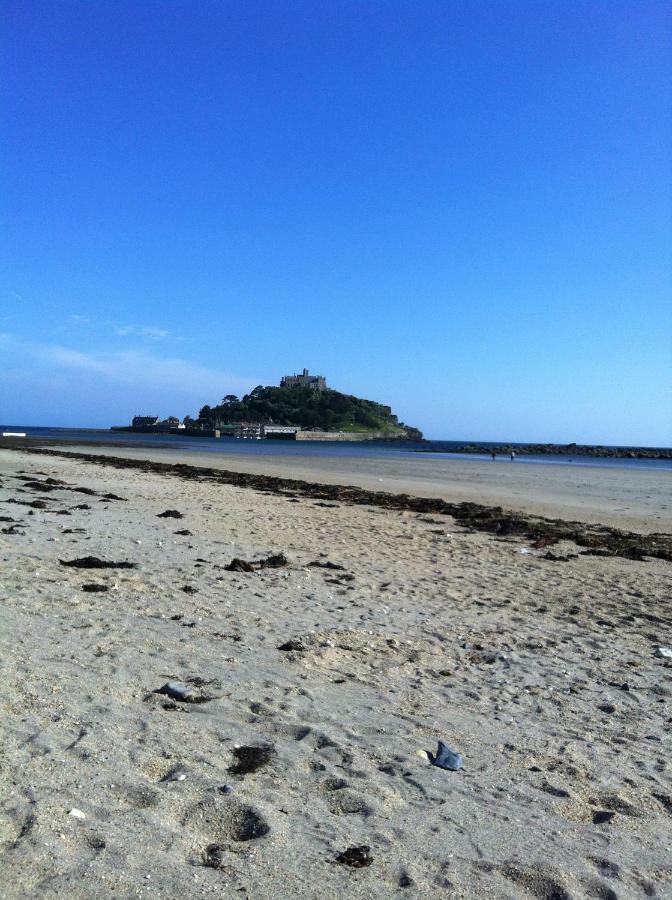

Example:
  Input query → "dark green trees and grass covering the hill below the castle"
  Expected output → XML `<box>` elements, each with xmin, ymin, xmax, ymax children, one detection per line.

<box><xmin>198</xmin><ymin>385</ymin><xmax>422</xmax><ymax>440</ymax></box>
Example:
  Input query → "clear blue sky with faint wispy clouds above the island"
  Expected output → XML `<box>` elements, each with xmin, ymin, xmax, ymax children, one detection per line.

<box><xmin>0</xmin><ymin>0</ymin><xmax>672</xmax><ymax>446</ymax></box>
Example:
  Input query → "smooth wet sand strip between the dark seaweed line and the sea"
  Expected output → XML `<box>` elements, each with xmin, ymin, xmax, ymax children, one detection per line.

<box><xmin>32</xmin><ymin>445</ymin><xmax>672</xmax><ymax>532</ymax></box>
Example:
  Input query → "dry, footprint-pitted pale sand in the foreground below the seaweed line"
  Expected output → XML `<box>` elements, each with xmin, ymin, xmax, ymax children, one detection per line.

<box><xmin>0</xmin><ymin>449</ymin><xmax>672</xmax><ymax>900</ymax></box>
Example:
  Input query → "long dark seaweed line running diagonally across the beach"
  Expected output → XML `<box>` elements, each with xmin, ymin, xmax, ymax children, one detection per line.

<box><xmin>6</xmin><ymin>446</ymin><xmax>672</xmax><ymax>562</ymax></box>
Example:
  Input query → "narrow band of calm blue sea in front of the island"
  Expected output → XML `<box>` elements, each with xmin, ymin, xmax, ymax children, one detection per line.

<box><xmin>0</xmin><ymin>425</ymin><xmax>672</xmax><ymax>470</ymax></box>
